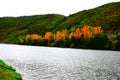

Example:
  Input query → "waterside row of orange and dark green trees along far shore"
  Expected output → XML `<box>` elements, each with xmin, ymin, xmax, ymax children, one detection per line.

<box><xmin>18</xmin><ymin>26</ymin><xmax>120</xmax><ymax>50</ymax></box>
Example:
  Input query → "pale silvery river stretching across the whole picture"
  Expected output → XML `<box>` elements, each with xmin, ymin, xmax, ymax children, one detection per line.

<box><xmin>0</xmin><ymin>44</ymin><xmax>120</xmax><ymax>80</ymax></box>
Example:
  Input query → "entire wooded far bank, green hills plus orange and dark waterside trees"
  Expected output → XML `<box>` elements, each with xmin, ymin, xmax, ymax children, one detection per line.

<box><xmin>0</xmin><ymin>2</ymin><xmax>120</xmax><ymax>50</ymax></box>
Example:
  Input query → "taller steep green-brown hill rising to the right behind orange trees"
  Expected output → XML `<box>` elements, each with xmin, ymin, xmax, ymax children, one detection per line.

<box><xmin>57</xmin><ymin>2</ymin><xmax>120</xmax><ymax>31</ymax></box>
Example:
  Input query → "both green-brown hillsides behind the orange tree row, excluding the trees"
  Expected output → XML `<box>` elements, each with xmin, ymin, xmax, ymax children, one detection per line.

<box><xmin>0</xmin><ymin>2</ymin><xmax>120</xmax><ymax>42</ymax></box>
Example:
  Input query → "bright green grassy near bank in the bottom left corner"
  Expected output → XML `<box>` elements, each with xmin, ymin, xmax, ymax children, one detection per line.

<box><xmin>0</xmin><ymin>60</ymin><xmax>22</xmax><ymax>80</ymax></box>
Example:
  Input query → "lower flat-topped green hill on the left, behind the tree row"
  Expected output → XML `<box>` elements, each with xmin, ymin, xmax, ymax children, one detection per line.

<box><xmin>0</xmin><ymin>14</ymin><xmax>65</xmax><ymax>42</ymax></box>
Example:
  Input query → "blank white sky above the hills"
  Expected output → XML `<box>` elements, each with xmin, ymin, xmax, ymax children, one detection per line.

<box><xmin>0</xmin><ymin>0</ymin><xmax>120</xmax><ymax>17</ymax></box>
